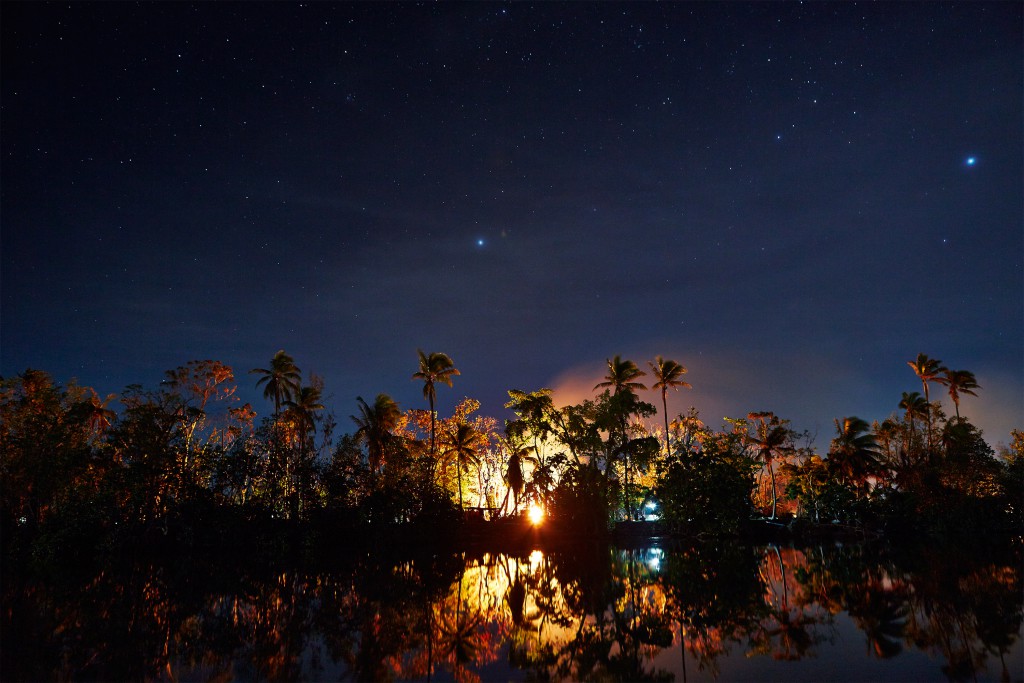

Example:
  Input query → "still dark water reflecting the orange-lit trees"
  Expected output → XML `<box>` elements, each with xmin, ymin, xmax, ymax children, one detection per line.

<box><xmin>3</xmin><ymin>543</ymin><xmax>1024</xmax><ymax>681</ymax></box>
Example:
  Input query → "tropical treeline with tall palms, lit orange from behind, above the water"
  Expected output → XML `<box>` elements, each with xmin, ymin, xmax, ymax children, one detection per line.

<box><xmin>0</xmin><ymin>351</ymin><xmax>1024</xmax><ymax>561</ymax></box>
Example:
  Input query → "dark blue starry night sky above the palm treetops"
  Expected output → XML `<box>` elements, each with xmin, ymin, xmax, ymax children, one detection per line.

<box><xmin>0</xmin><ymin>2</ymin><xmax>1024</xmax><ymax>445</ymax></box>
